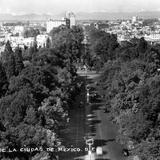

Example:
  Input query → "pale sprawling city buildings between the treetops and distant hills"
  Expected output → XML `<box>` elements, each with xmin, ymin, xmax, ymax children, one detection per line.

<box><xmin>0</xmin><ymin>12</ymin><xmax>160</xmax><ymax>52</ymax></box>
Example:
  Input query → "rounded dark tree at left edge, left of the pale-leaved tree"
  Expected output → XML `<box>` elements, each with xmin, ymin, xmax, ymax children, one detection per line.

<box><xmin>0</xmin><ymin>88</ymin><xmax>35</xmax><ymax>126</ymax></box>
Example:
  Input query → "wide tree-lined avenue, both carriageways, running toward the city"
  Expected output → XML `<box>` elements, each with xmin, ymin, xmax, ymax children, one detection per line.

<box><xmin>59</xmin><ymin>72</ymin><xmax>125</xmax><ymax>160</ymax></box>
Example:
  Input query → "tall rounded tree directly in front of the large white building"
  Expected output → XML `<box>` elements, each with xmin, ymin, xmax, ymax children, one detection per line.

<box><xmin>50</xmin><ymin>26</ymin><xmax>83</xmax><ymax>62</ymax></box>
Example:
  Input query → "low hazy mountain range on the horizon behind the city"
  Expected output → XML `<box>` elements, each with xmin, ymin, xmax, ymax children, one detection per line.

<box><xmin>0</xmin><ymin>11</ymin><xmax>160</xmax><ymax>21</ymax></box>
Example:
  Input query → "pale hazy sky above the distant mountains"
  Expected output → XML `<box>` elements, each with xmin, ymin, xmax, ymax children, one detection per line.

<box><xmin>0</xmin><ymin>0</ymin><xmax>160</xmax><ymax>14</ymax></box>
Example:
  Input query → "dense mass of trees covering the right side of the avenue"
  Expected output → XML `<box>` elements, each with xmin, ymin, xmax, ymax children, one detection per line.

<box><xmin>90</xmin><ymin>26</ymin><xmax>160</xmax><ymax>160</ymax></box>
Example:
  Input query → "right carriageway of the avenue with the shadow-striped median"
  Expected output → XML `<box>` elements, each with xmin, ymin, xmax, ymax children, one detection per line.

<box><xmin>77</xmin><ymin>72</ymin><xmax>125</xmax><ymax>160</ymax></box>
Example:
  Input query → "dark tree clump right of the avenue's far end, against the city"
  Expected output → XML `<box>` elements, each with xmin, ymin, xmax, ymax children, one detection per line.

<box><xmin>83</xmin><ymin>27</ymin><xmax>119</xmax><ymax>70</ymax></box>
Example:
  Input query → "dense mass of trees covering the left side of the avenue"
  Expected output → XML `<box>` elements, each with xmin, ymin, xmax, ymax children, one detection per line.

<box><xmin>0</xmin><ymin>27</ymin><xmax>83</xmax><ymax>160</ymax></box>
